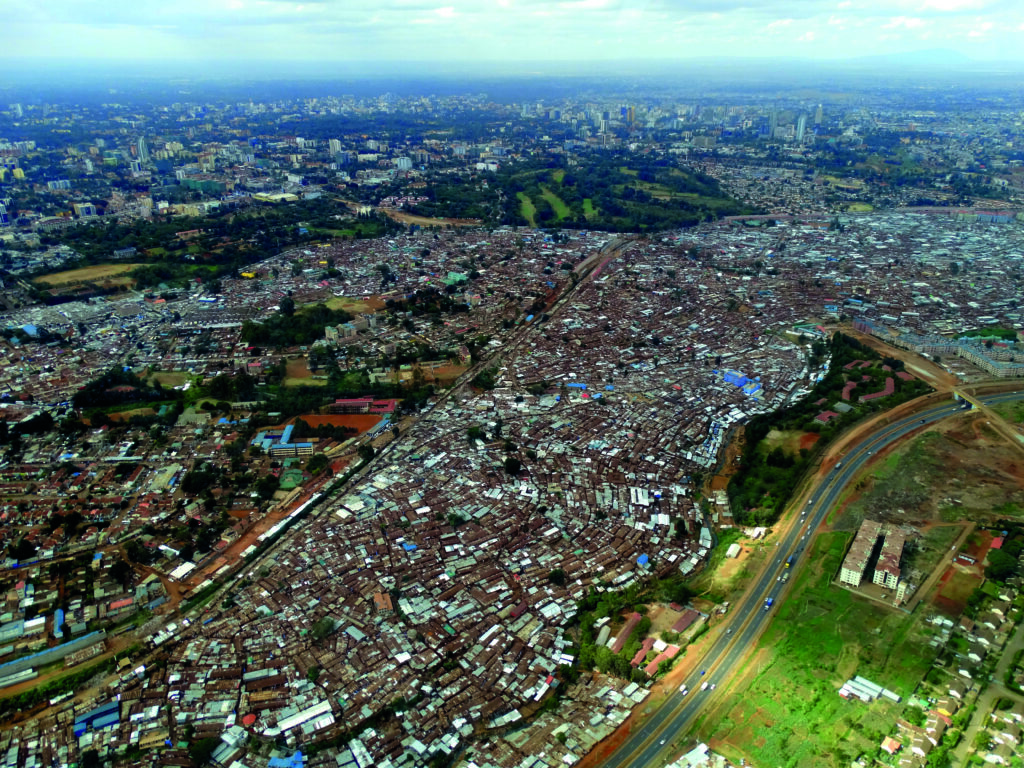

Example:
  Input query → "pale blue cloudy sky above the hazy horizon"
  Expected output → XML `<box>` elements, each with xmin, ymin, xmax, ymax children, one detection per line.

<box><xmin>6</xmin><ymin>0</ymin><xmax>1024</xmax><ymax>68</ymax></box>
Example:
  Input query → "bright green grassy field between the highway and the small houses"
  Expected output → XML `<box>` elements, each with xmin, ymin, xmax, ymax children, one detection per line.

<box><xmin>700</xmin><ymin>532</ymin><xmax>935</xmax><ymax>768</ymax></box>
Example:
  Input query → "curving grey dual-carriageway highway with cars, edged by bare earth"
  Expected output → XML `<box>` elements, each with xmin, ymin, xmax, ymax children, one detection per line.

<box><xmin>603</xmin><ymin>392</ymin><xmax>1024</xmax><ymax>768</ymax></box>
